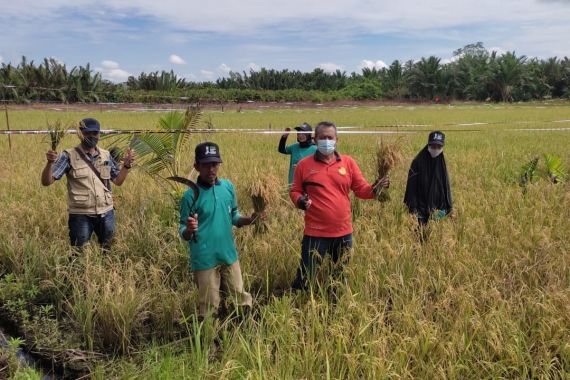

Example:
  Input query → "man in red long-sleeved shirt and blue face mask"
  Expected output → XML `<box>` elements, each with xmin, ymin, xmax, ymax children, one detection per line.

<box><xmin>289</xmin><ymin>121</ymin><xmax>390</xmax><ymax>290</ymax></box>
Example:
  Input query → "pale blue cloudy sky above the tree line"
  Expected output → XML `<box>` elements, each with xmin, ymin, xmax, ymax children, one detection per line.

<box><xmin>0</xmin><ymin>0</ymin><xmax>570</xmax><ymax>82</ymax></box>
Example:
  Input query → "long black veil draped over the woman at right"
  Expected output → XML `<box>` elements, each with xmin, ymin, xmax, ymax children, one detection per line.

<box><xmin>404</xmin><ymin>145</ymin><xmax>453</xmax><ymax>216</ymax></box>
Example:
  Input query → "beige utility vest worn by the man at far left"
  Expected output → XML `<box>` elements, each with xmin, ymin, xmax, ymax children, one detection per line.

<box><xmin>66</xmin><ymin>147</ymin><xmax>113</xmax><ymax>215</ymax></box>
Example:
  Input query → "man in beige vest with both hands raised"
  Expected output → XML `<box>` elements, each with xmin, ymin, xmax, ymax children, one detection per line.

<box><xmin>42</xmin><ymin>118</ymin><xmax>134</xmax><ymax>248</ymax></box>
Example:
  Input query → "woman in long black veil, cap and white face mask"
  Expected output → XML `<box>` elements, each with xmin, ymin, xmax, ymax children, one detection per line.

<box><xmin>404</xmin><ymin>131</ymin><xmax>453</xmax><ymax>225</ymax></box>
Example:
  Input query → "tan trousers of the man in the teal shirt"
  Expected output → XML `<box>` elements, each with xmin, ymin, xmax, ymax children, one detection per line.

<box><xmin>194</xmin><ymin>260</ymin><xmax>252</xmax><ymax>317</ymax></box>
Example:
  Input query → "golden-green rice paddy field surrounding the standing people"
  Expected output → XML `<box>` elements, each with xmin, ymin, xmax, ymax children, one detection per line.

<box><xmin>0</xmin><ymin>102</ymin><xmax>570</xmax><ymax>379</ymax></box>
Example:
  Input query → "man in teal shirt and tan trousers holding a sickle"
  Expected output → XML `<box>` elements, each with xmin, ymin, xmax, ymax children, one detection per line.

<box><xmin>179</xmin><ymin>142</ymin><xmax>265</xmax><ymax>318</ymax></box>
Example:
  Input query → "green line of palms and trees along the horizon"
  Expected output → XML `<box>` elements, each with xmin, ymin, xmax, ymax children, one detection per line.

<box><xmin>0</xmin><ymin>42</ymin><xmax>570</xmax><ymax>103</ymax></box>
